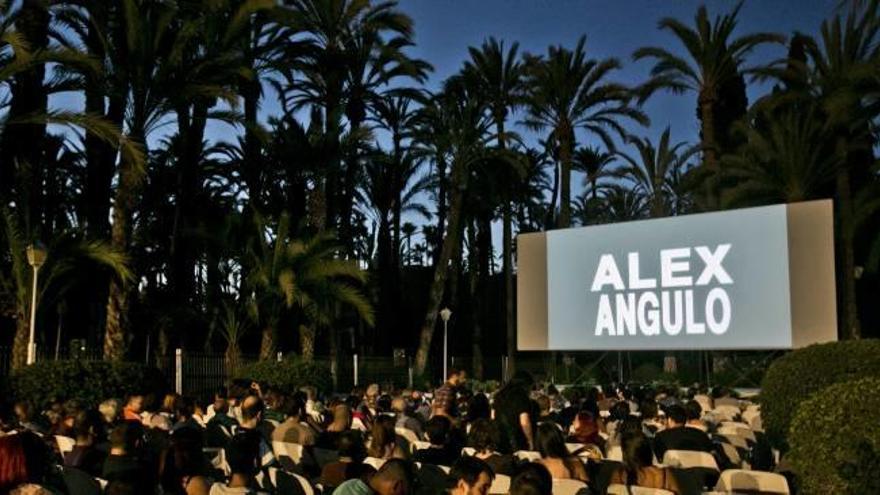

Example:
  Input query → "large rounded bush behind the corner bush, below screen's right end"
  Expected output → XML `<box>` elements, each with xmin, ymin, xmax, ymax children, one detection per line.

<box><xmin>760</xmin><ymin>340</ymin><xmax>880</xmax><ymax>450</ymax></box>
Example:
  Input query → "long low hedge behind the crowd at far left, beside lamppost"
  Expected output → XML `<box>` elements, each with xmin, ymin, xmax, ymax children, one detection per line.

<box><xmin>9</xmin><ymin>360</ymin><xmax>167</xmax><ymax>408</ymax></box>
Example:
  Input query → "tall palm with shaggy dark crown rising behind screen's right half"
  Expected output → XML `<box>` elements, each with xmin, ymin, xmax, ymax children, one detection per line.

<box><xmin>633</xmin><ymin>2</ymin><xmax>785</xmax><ymax>208</ymax></box>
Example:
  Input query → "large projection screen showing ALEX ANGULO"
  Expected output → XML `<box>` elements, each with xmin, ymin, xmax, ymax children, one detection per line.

<box><xmin>517</xmin><ymin>201</ymin><xmax>837</xmax><ymax>351</ymax></box>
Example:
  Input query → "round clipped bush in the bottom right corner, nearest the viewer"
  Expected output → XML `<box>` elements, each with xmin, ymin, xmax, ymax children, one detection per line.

<box><xmin>788</xmin><ymin>378</ymin><xmax>880</xmax><ymax>494</ymax></box>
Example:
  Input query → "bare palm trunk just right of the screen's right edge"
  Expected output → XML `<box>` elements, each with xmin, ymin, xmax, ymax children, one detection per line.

<box><xmin>835</xmin><ymin>164</ymin><xmax>862</xmax><ymax>339</ymax></box>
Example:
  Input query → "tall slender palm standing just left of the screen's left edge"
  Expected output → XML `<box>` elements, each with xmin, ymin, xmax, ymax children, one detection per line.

<box><xmin>464</xmin><ymin>37</ymin><xmax>525</xmax><ymax>376</ymax></box>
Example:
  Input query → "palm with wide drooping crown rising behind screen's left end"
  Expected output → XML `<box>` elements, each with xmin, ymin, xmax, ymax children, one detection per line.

<box><xmin>524</xmin><ymin>37</ymin><xmax>648</xmax><ymax>228</ymax></box>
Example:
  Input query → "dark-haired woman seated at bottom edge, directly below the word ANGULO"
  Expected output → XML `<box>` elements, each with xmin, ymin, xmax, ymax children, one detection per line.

<box><xmin>610</xmin><ymin>432</ymin><xmax>681</xmax><ymax>493</ymax></box>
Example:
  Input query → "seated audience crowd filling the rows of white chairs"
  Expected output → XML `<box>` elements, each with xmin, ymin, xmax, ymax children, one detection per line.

<box><xmin>0</xmin><ymin>369</ymin><xmax>763</xmax><ymax>495</ymax></box>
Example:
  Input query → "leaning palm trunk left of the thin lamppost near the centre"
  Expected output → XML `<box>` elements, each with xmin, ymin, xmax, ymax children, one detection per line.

<box><xmin>415</xmin><ymin>160</ymin><xmax>467</xmax><ymax>376</ymax></box>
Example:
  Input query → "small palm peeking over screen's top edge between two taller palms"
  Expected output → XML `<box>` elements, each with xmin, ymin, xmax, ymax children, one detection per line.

<box><xmin>614</xmin><ymin>127</ymin><xmax>698</xmax><ymax>218</ymax></box>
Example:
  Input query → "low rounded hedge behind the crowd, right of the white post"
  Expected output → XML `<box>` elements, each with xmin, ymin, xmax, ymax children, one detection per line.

<box><xmin>236</xmin><ymin>357</ymin><xmax>332</xmax><ymax>394</ymax></box>
